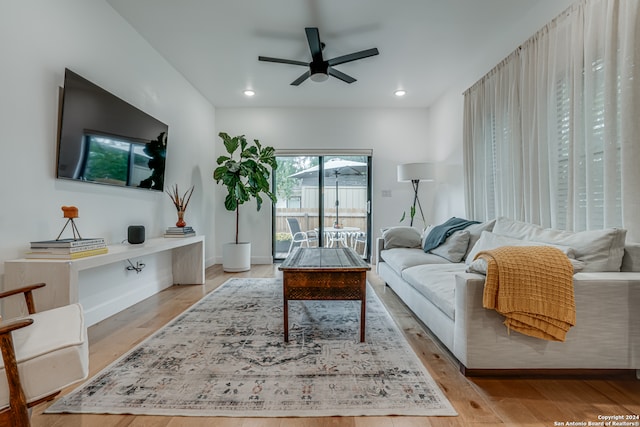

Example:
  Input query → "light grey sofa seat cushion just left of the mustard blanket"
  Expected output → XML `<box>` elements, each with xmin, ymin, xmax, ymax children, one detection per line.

<box><xmin>402</xmin><ymin>263</ymin><xmax>465</xmax><ymax>320</ymax></box>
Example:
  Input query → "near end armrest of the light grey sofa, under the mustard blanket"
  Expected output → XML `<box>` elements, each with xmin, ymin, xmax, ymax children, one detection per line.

<box><xmin>452</xmin><ymin>272</ymin><xmax>640</xmax><ymax>369</ymax></box>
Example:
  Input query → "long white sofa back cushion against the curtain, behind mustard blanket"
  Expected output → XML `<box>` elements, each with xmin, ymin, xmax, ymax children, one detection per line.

<box><xmin>493</xmin><ymin>217</ymin><xmax>627</xmax><ymax>272</ymax></box>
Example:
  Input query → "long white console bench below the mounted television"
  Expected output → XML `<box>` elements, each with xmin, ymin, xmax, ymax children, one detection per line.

<box><xmin>2</xmin><ymin>236</ymin><xmax>205</xmax><ymax>325</ymax></box>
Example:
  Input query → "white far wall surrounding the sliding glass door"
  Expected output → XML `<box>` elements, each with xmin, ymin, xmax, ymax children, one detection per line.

<box><xmin>215</xmin><ymin>108</ymin><xmax>444</xmax><ymax>263</ymax></box>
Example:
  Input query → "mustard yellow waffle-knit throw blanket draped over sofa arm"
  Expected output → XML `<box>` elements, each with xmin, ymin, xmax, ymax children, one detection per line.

<box><xmin>476</xmin><ymin>246</ymin><xmax>576</xmax><ymax>341</ymax></box>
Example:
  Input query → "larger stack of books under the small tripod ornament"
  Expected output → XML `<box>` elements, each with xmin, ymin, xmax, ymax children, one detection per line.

<box><xmin>25</xmin><ymin>237</ymin><xmax>109</xmax><ymax>259</ymax></box>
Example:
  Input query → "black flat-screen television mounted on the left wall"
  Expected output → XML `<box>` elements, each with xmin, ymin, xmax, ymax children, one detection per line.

<box><xmin>57</xmin><ymin>69</ymin><xmax>169</xmax><ymax>191</ymax></box>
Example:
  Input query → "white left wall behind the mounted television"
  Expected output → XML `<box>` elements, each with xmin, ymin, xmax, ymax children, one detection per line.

<box><xmin>0</xmin><ymin>0</ymin><xmax>216</xmax><ymax>318</ymax></box>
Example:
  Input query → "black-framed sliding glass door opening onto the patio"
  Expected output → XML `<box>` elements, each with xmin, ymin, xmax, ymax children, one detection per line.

<box><xmin>273</xmin><ymin>154</ymin><xmax>371</xmax><ymax>260</ymax></box>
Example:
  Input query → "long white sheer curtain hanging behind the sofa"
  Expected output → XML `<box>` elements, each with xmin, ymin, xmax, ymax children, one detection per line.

<box><xmin>464</xmin><ymin>0</ymin><xmax>640</xmax><ymax>241</ymax></box>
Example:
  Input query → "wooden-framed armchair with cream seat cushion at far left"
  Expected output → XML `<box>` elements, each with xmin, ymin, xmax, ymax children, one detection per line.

<box><xmin>0</xmin><ymin>283</ymin><xmax>89</xmax><ymax>427</ymax></box>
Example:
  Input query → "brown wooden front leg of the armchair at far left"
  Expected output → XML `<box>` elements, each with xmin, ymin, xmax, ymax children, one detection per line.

<box><xmin>0</xmin><ymin>332</ymin><xmax>31</xmax><ymax>427</ymax></box>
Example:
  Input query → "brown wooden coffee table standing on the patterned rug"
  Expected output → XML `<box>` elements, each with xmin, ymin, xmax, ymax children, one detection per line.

<box><xmin>279</xmin><ymin>248</ymin><xmax>371</xmax><ymax>342</ymax></box>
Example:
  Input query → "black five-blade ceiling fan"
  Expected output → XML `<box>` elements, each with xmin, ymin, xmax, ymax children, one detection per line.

<box><xmin>258</xmin><ymin>27</ymin><xmax>379</xmax><ymax>86</ymax></box>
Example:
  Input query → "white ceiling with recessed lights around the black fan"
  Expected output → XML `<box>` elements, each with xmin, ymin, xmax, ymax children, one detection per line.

<box><xmin>107</xmin><ymin>0</ymin><xmax>556</xmax><ymax>107</ymax></box>
